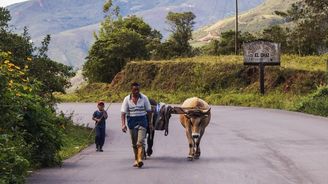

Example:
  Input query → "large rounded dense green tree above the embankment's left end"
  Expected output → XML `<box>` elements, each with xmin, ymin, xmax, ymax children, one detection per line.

<box><xmin>83</xmin><ymin>26</ymin><xmax>147</xmax><ymax>82</ymax></box>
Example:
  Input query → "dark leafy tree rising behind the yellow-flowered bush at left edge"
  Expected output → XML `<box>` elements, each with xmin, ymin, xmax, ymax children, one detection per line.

<box><xmin>0</xmin><ymin>8</ymin><xmax>74</xmax><ymax>95</ymax></box>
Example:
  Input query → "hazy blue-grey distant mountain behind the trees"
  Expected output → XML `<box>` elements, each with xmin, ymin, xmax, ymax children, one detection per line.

<box><xmin>8</xmin><ymin>0</ymin><xmax>264</xmax><ymax>67</ymax></box>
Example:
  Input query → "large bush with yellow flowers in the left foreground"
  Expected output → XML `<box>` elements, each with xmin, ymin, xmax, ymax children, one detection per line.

<box><xmin>0</xmin><ymin>52</ymin><xmax>63</xmax><ymax>183</ymax></box>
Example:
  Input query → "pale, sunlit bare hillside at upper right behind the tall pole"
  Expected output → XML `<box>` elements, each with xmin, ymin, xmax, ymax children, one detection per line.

<box><xmin>193</xmin><ymin>0</ymin><xmax>299</xmax><ymax>45</ymax></box>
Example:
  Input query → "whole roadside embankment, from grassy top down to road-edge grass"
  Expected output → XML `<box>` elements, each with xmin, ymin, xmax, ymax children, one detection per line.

<box><xmin>56</xmin><ymin>55</ymin><xmax>328</xmax><ymax>116</ymax></box>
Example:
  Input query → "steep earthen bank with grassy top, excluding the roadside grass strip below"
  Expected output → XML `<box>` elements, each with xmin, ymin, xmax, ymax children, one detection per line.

<box><xmin>112</xmin><ymin>56</ymin><xmax>326</xmax><ymax>94</ymax></box>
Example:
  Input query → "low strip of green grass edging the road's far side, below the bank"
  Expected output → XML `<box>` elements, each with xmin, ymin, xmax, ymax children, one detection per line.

<box><xmin>56</xmin><ymin>87</ymin><xmax>320</xmax><ymax>114</ymax></box>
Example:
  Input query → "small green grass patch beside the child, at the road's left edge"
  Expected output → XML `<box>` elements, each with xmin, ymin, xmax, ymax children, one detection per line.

<box><xmin>59</xmin><ymin>125</ymin><xmax>94</xmax><ymax>159</ymax></box>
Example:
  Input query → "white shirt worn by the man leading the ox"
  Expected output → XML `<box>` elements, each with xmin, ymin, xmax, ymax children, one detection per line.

<box><xmin>121</xmin><ymin>93</ymin><xmax>151</xmax><ymax>117</ymax></box>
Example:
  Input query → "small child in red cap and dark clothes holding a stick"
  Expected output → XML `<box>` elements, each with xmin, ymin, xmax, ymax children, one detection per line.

<box><xmin>92</xmin><ymin>101</ymin><xmax>108</xmax><ymax>152</ymax></box>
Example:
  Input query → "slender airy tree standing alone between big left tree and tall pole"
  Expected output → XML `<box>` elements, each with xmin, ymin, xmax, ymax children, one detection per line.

<box><xmin>163</xmin><ymin>12</ymin><xmax>196</xmax><ymax>57</ymax></box>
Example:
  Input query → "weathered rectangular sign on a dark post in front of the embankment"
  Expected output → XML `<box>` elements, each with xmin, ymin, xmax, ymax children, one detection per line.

<box><xmin>243</xmin><ymin>41</ymin><xmax>280</xmax><ymax>95</ymax></box>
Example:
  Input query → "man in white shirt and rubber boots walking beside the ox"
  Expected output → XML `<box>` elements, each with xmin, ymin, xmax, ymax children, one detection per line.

<box><xmin>121</xmin><ymin>83</ymin><xmax>153</xmax><ymax>168</ymax></box>
